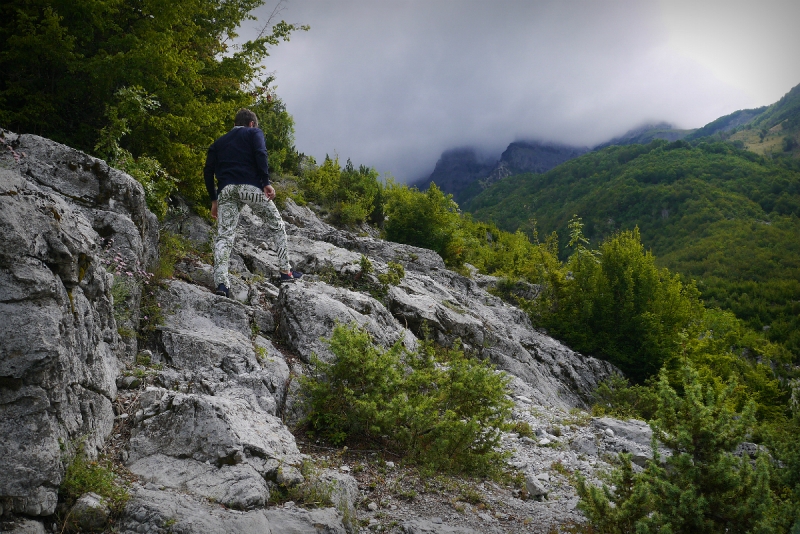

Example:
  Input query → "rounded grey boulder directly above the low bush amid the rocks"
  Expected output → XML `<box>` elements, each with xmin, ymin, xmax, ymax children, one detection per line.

<box><xmin>278</xmin><ymin>282</ymin><xmax>416</xmax><ymax>362</ymax></box>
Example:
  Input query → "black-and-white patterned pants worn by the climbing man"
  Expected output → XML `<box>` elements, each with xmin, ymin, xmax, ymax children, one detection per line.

<box><xmin>214</xmin><ymin>184</ymin><xmax>292</xmax><ymax>288</ymax></box>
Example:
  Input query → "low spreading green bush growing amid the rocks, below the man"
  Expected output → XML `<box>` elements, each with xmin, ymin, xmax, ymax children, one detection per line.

<box><xmin>302</xmin><ymin>325</ymin><xmax>511</xmax><ymax>473</ymax></box>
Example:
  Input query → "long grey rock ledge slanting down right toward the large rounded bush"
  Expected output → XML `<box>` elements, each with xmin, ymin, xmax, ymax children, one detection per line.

<box><xmin>388</xmin><ymin>271</ymin><xmax>613</xmax><ymax>407</ymax></box>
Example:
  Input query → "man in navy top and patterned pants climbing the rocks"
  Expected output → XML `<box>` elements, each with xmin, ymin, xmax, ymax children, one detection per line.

<box><xmin>203</xmin><ymin>109</ymin><xmax>303</xmax><ymax>297</ymax></box>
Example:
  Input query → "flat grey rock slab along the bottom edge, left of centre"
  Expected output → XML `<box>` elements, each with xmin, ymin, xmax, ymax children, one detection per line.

<box><xmin>121</xmin><ymin>488</ymin><xmax>345</xmax><ymax>534</ymax></box>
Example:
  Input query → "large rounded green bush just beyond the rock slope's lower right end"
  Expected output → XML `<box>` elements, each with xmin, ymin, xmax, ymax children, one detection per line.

<box><xmin>529</xmin><ymin>226</ymin><xmax>703</xmax><ymax>382</ymax></box>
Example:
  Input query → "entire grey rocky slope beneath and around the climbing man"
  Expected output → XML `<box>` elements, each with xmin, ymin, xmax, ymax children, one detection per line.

<box><xmin>0</xmin><ymin>132</ymin><xmax>632</xmax><ymax>532</ymax></box>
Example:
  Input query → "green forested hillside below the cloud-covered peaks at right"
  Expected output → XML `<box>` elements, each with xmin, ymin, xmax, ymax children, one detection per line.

<box><xmin>466</xmin><ymin>141</ymin><xmax>800</xmax><ymax>354</ymax></box>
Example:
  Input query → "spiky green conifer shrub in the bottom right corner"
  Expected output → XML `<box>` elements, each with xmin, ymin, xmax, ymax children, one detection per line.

<box><xmin>577</xmin><ymin>367</ymin><xmax>788</xmax><ymax>534</ymax></box>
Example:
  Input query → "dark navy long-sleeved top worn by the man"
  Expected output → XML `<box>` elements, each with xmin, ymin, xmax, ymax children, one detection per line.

<box><xmin>203</xmin><ymin>126</ymin><xmax>269</xmax><ymax>200</ymax></box>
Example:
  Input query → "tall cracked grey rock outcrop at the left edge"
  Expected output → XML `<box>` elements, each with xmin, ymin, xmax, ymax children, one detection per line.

<box><xmin>0</xmin><ymin>132</ymin><xmax>158</xmax><ymax>516</ymax></box>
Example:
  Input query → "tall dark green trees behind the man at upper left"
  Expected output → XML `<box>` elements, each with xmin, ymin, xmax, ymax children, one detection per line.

<box><xmin>0</xmin><ymin>0</ymin><xmax>308</xmax><ymax>206</ymax></box>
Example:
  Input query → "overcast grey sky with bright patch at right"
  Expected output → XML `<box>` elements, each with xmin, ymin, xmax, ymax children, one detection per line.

<box><xmin>241</xmin><ymin>0</ymin><xmax>800</xmax><ymax>181</ymax></box>
